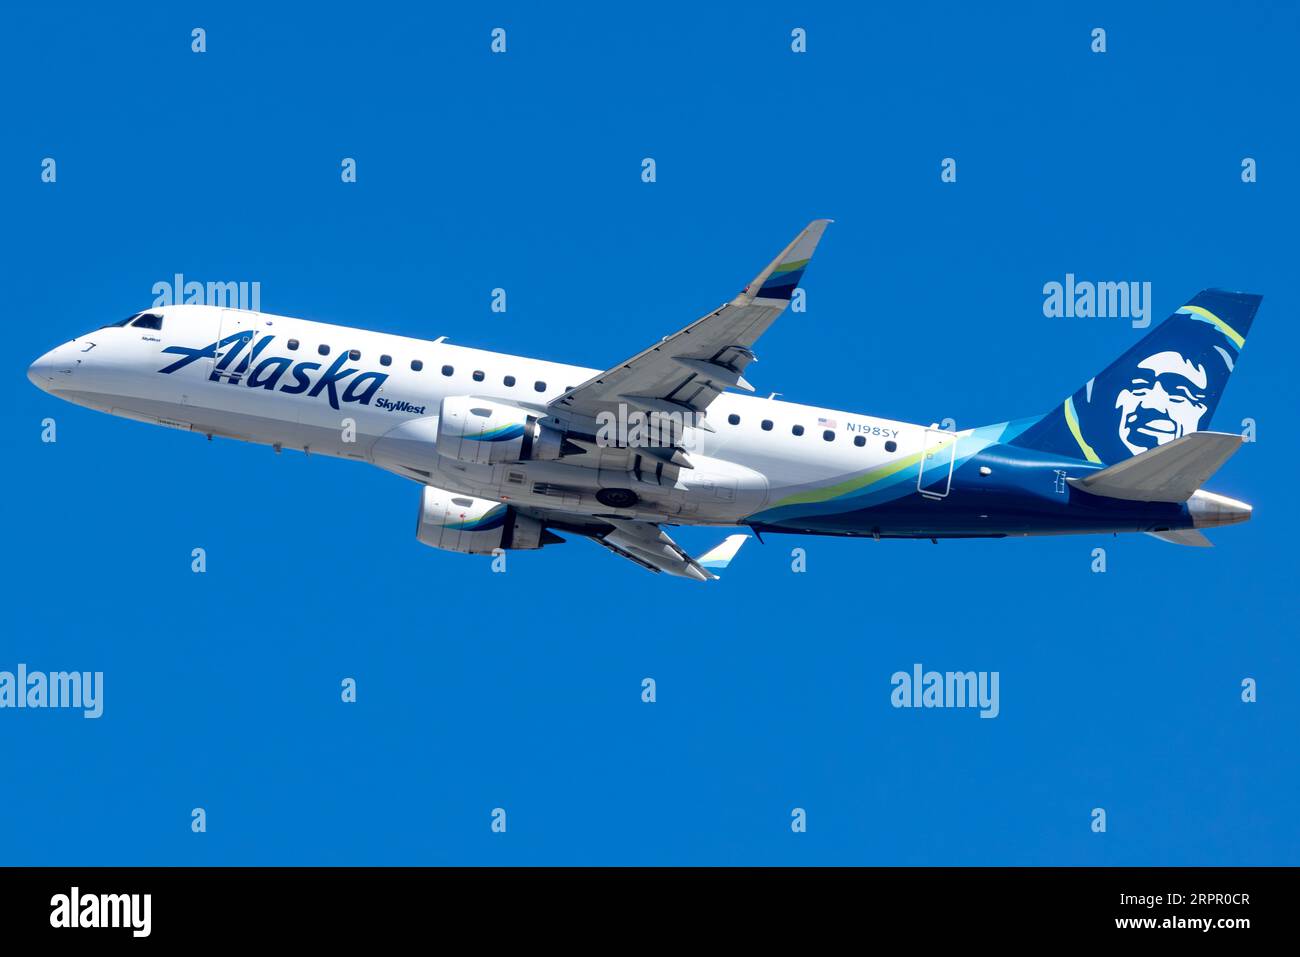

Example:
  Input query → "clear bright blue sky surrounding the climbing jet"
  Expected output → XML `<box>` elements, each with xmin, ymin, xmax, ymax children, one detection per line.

<box><xmin>0</xmin><ymin>3</ymin><xmax>1300</xmax><ymax>865</ymax></box>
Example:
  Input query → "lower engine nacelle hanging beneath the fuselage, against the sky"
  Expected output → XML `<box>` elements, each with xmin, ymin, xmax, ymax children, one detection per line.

<box><xmin>415</xmin><ymin>485</ymin><xmax>548</xmax><ymax>555</ymax></box>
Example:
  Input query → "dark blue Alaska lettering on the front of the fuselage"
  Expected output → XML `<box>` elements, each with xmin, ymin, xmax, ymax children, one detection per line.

<box><xmin>159</xmin><ymin>329</ymin><xmax>389</xmax><ymax>408</ymax></box>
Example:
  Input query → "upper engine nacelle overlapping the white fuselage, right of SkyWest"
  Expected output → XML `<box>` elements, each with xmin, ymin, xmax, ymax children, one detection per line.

<box><xmin>436</xmin><ymin>395</ymin><xmax>564</xmax><ymax>465</ymax></box>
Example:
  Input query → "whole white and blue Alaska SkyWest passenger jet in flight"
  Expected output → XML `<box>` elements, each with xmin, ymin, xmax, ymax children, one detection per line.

<box><xmin>27</xmin><ymin>220</ymin><xmax>1261</xmax><ymax>581</ymax></box>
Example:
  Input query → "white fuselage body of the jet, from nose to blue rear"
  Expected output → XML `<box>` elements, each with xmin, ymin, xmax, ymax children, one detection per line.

<box><xmin>29</xmin><ymin>306</ymin><xmax>932</xmax><ymax>524</ymax></box>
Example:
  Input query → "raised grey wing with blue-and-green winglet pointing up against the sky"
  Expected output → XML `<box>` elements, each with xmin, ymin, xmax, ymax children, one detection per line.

<box><xmin>550</xmin><ymin>220</ymin><xmax>831</xmax><ymax>428</ymax></box>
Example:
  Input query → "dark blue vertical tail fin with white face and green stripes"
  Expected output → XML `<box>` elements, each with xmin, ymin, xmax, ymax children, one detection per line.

<box><xmin>1011</xmin><ymin>289</ymin><xmax>1264</xmax><ymax>464</ymax></box>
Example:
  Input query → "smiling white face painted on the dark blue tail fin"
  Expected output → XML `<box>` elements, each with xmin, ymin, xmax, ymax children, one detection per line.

<box><xmin>1115</xmin><ymin>351</ymin><xmax>1209</xmax><ymax>455</ymax></box>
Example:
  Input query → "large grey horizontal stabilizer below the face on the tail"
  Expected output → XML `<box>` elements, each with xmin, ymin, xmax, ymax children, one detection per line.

<box><xmin>1069</xmin><ymin>432</ymin><xmax>1244</xmax><ymax>502</ymax></box>
